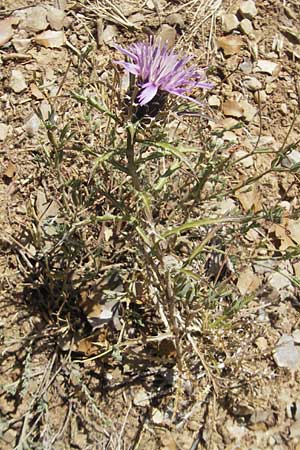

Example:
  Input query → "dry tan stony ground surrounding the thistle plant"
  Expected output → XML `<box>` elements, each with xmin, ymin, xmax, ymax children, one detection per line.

<box><xmin>0</xmin><ymin>0</ymin><xmax>300</xmax><ymax>450</ymax></box>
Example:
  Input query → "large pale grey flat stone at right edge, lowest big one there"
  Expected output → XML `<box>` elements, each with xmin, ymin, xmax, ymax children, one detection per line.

<box><xmin>273</xmin><ymin>334</ymin><xmax>300</xmax><ymax>370</ymax></box>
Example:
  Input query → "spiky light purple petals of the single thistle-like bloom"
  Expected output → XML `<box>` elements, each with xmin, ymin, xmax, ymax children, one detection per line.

<box><xmin>115</xmin><ymin>39</ymin><xmax>213</xmax><ymax>106</ymax></box>
